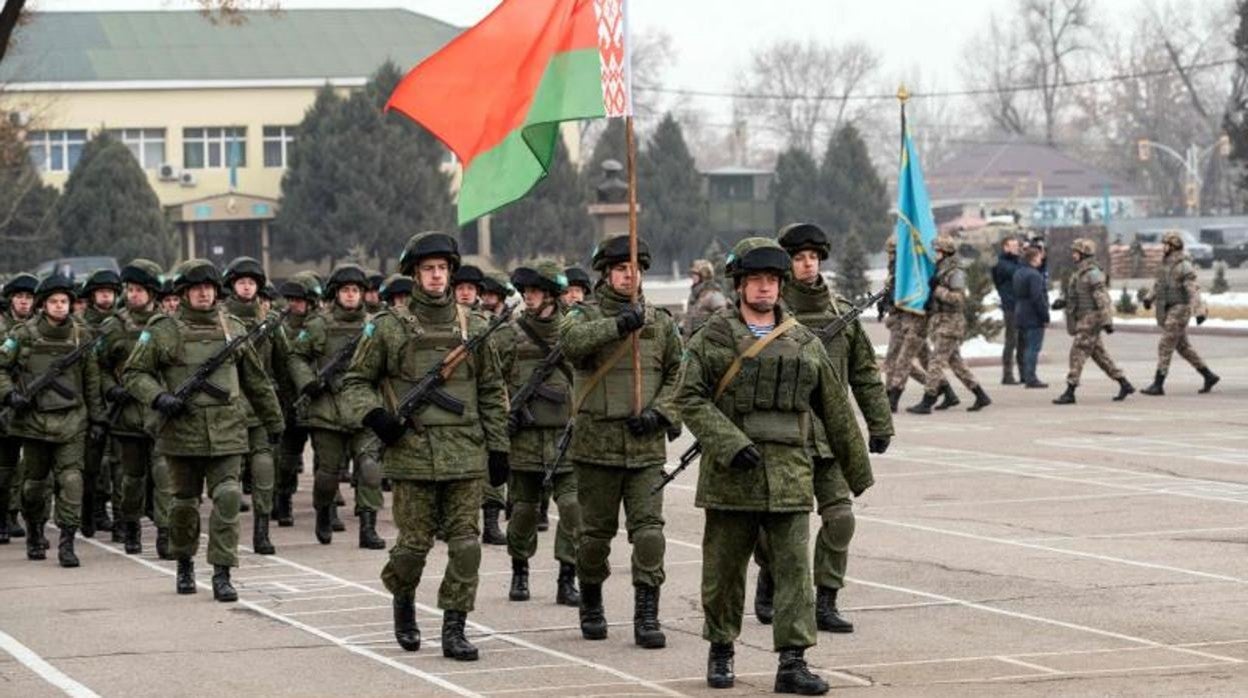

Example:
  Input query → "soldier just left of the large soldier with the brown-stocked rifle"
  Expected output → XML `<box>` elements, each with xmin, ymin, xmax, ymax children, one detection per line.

<box><xmin>290</xmin><ymin>265</ymin><xmax>386</xmax><ymax>551</ymax></box>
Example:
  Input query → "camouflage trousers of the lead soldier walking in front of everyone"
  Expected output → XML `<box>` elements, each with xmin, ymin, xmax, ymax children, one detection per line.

<box><xmin>701</xmin><ymin>509</ymin><xmax>815</xmax><ymax>649</ymax></box>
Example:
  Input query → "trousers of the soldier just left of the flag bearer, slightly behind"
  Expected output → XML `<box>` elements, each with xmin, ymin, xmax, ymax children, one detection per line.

<box><xmin>507</xmin><ymin>469</ymin><xmax>580</xmax><ymax>564</ymax></box>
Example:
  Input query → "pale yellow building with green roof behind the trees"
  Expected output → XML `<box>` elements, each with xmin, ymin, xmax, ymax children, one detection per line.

<box><xmin>0</xmin><ymin>9</ymin><xmax>469</xmax><ymax>273</ymax></box>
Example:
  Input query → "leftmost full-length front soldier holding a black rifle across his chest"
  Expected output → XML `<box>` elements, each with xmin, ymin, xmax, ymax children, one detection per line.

<box><xmin>0</xmin><ymin>275</ymin><xmax>105</xmax><ymax>567</ymax></box>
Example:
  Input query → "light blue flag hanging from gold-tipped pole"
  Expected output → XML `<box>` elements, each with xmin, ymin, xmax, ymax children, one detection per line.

<box><xmin>892</xmin><ymin>104</ymin><xmax>936</xmax><ymax>315</ymax></box>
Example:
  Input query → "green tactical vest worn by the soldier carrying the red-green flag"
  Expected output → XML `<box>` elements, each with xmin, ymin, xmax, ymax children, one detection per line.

<box><xmin>577</xmin><ymin>306</ymin><xmax>664</xmax><ymax>420</ymax></box>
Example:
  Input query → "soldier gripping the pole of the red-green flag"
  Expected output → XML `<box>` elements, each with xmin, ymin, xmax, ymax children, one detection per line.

<box><xmin>559</xmin><ymin>235</ymin><xmax>681</xmax><ymax>649</ymax></box>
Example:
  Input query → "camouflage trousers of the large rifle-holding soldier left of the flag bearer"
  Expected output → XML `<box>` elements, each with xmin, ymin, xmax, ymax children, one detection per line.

<box><xmin>382</xmin><ymin>478</ymin><xmax>482</xmax><ymax>613</ymax></box>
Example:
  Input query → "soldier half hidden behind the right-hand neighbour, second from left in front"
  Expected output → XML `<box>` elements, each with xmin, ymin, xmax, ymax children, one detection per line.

<box><xmin>97</xmin><ymin>258</ymin><xmax>172</xmax><ymax>559</ymax></box>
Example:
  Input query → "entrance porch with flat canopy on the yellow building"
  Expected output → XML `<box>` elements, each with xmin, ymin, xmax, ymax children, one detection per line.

<box><xmin>166</xmin><ymin>192</ymin><xmax>278</xmax><ymax>272</ymax></box>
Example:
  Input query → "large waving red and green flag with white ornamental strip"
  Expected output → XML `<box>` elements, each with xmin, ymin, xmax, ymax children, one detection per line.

<box><xmin>386</xmin><ymin>0</ymin><xmax>633</xmax><ymax>225</ymax></box>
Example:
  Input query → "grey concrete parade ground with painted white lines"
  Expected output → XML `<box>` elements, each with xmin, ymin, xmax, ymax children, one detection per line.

<box><xmin>0</xmin><ymin>323</ymin><xmax>1248</xmax><ymax>698</ymax></box>
